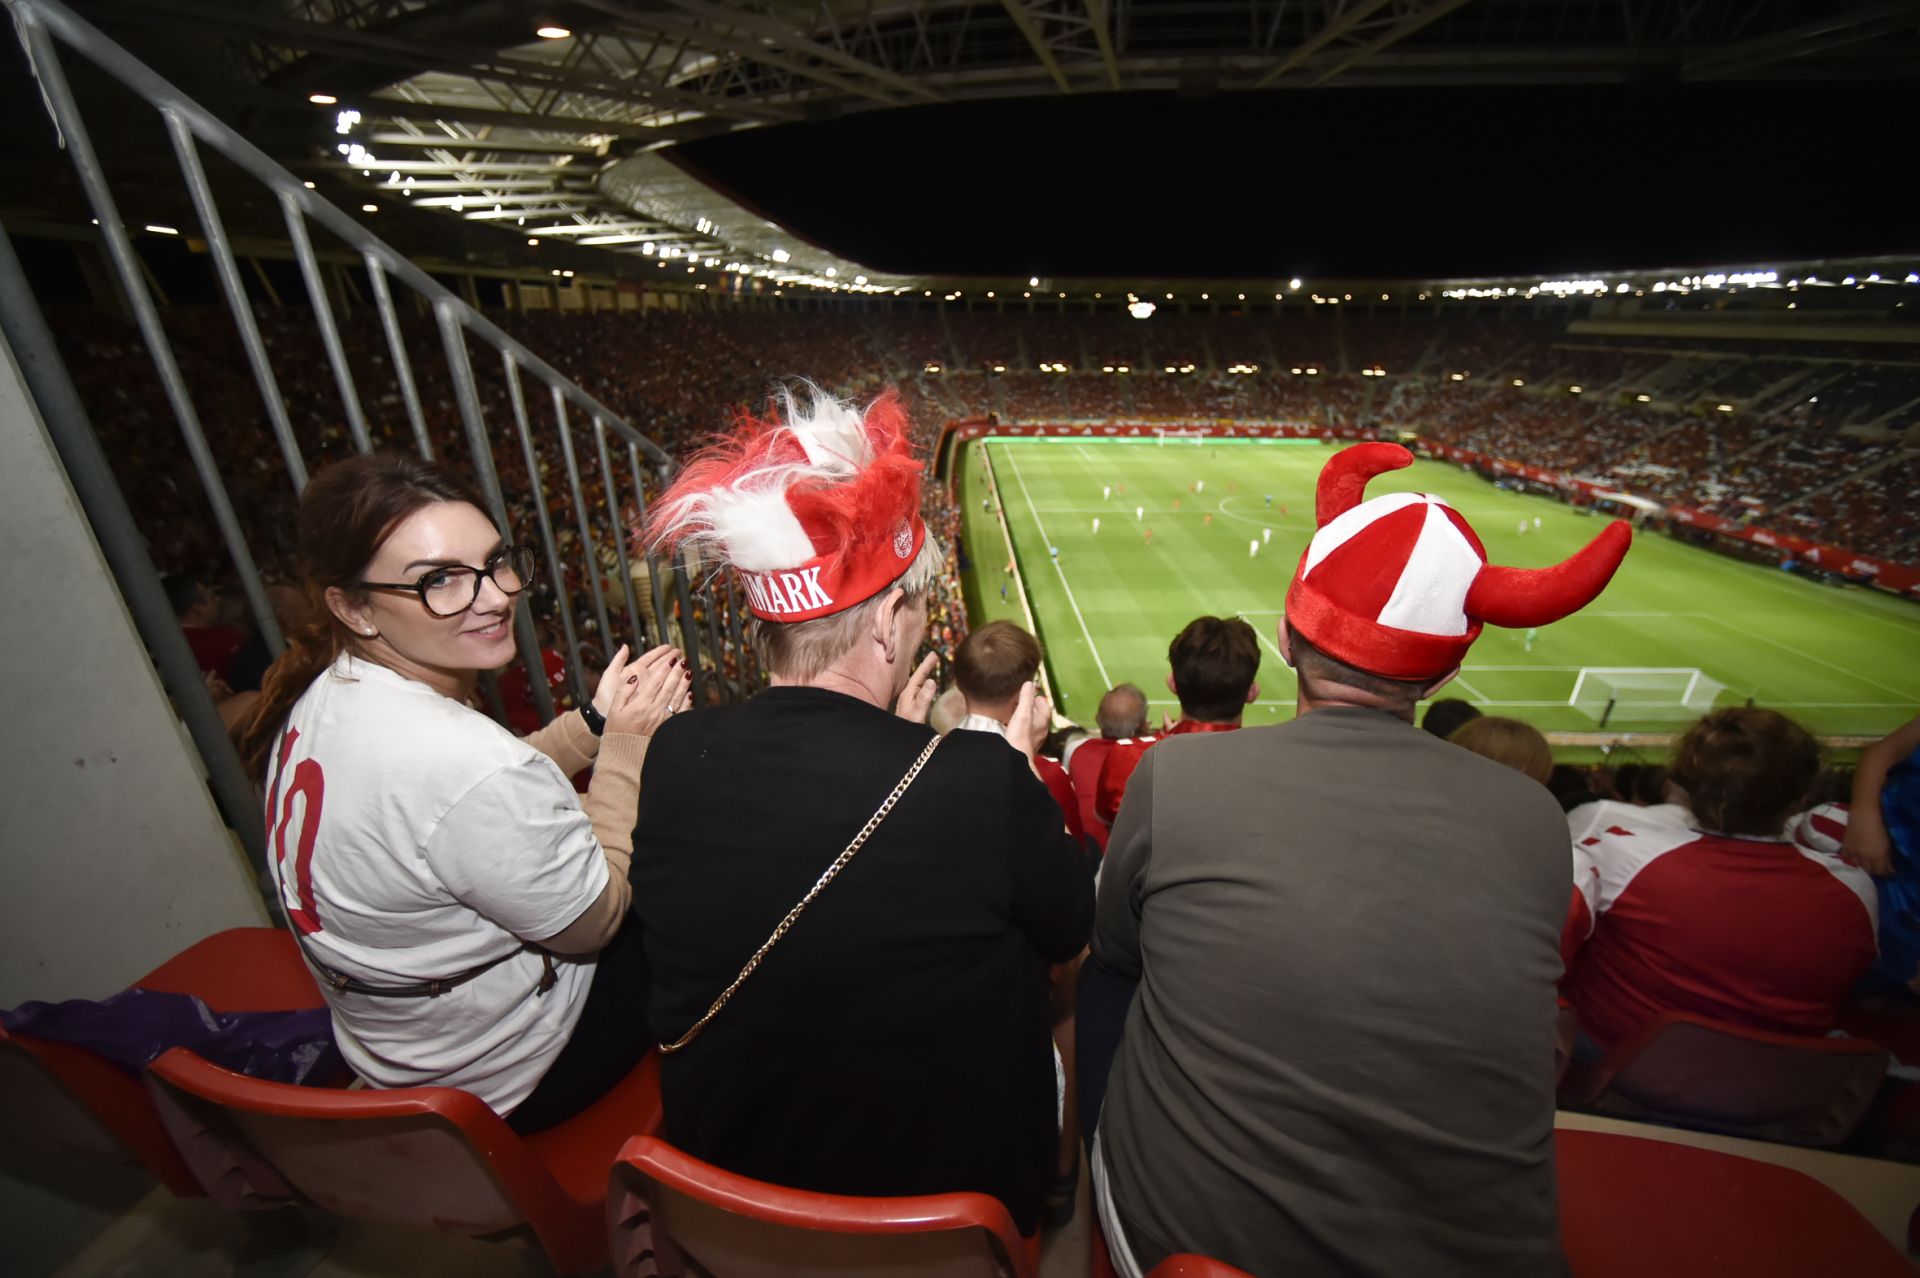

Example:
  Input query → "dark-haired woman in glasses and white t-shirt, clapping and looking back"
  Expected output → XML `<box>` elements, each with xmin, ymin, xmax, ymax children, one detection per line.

<box><xmin>242</xmin><ymin>455</ymin><xmax>689</xmax><ymax>1132</ymax></box>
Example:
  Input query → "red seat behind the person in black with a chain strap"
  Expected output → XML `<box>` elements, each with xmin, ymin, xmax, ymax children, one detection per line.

<box><xmin>607</xmin><ymin>1136</ymin><xmax>1039</xmax><ymax>1278</ymax></box>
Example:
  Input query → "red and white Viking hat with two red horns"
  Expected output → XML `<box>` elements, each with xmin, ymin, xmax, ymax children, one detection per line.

<box><xmin>1286</xmin><ymin>443</ymin><xmax>1634</xmax><ymax>681</ymax></box>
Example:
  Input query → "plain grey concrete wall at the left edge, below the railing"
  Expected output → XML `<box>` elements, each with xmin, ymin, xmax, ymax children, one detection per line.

<box><xmin>0</xmin><ymin>335</ymin><xmax>267</xmax><ymax>1007</ymax></box>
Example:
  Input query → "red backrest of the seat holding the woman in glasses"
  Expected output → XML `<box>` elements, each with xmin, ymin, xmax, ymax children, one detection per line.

<box><xmin>148</xmin><ymin>1048</ymin><xmax>561</xmax><ymax>1236</ymax></box>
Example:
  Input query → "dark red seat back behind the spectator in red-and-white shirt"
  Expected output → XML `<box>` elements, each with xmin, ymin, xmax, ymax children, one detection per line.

<box><xmin>1559</xmin><ymin>1011</ymin><xmax>1891</xmax><ymax>1146</ymax></box>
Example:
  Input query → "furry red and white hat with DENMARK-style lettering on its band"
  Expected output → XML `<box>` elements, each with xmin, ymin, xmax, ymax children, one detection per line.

<box><xmin>641</xmin><ymin>382</ymin><xmax>927</xmax><ymax>622</ymax></box>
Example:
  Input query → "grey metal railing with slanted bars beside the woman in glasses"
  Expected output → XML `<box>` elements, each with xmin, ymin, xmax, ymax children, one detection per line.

<box><xmin>0</xmin><ymin>0</ymin><xmax>749</xmax><ymax>869</ymax></box>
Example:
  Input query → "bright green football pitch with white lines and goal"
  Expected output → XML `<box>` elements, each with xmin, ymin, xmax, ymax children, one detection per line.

<box><xmin>956</xmin><ymin>438</ymin><xmax>1920</xmax><ymax>758</ymax></box>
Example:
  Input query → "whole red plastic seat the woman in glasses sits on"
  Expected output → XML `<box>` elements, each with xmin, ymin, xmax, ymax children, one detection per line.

<box><xmin>148</xmin><ymin>1048</ymin><xmax>660</xmax><ymax>1274</ymax></box>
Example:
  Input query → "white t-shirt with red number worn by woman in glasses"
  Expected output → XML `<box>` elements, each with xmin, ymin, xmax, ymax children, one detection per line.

<box><xmin>267</xmin><ymin>654</ymin><xmax>607</xmax><ymax>1113</ymax></box>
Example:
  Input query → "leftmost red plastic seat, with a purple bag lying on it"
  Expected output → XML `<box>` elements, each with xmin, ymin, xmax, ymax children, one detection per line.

<box><xmin>0</xmin><ymin>927</ymin><xmax>323</xmax><ymax>1197</ymax></box>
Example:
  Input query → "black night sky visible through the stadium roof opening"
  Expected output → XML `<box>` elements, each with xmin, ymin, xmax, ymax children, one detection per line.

<box><xmin>682</xmin><ymin>81</ymin><xmax>1920</xmax><ymax>278</ymax></box>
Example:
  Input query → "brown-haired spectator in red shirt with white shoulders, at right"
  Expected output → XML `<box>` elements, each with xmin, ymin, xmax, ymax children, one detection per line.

<box><xmin>1561</xmin><ymin>706</ymin><xmax>1876</xmax><ymax>1048</ymax></box>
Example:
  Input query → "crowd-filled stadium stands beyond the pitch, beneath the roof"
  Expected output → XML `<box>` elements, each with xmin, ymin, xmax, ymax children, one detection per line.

<box><xmin>56</xmin><ymin>307</ymin><xmax>1920</xmax><ymax>566</ymax></box>
